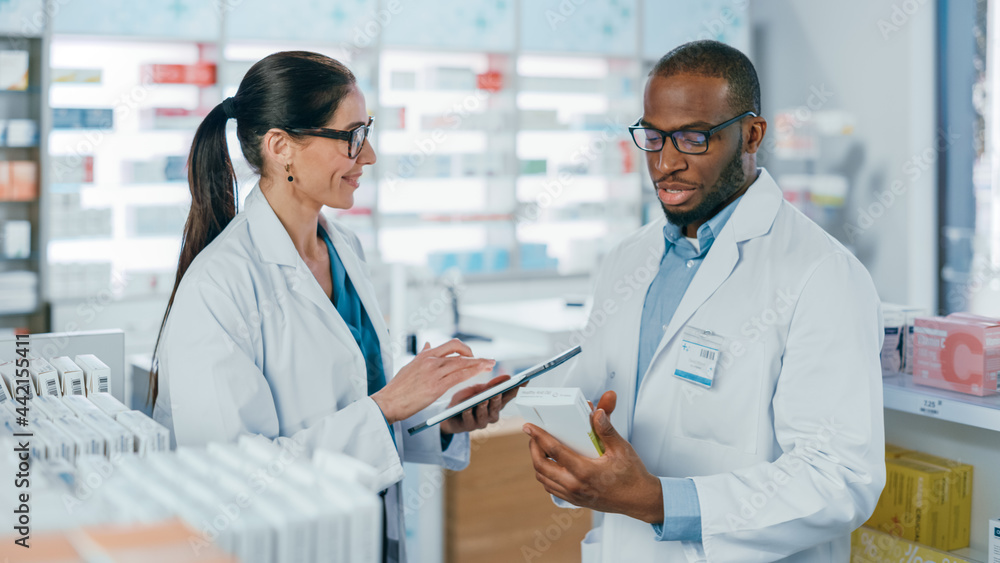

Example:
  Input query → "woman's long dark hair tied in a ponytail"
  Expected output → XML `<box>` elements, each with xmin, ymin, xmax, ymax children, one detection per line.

<box><xmin>148</xmin><ymin>51</ymin><xmax>355</xmax><ymax>406</ymax></box>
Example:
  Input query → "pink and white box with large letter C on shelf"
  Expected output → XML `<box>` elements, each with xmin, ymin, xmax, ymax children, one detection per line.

<box><xmin>913</xmin><ymin>313</ymin><xmax>1000</xmax><ymax>397</ymax></box>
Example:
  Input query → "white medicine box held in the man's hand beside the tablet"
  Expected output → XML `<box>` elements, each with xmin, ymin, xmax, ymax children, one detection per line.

<box><xmin>514</xmin><ymin>387</ymin><xmax>604</xmax><ymax>458</ymax></box>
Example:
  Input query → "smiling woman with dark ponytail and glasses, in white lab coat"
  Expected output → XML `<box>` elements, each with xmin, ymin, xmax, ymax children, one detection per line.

<box><xmin>150</xmin><ymin>52</ymin><xmax>514</xmax><ymax>560</ymax></box>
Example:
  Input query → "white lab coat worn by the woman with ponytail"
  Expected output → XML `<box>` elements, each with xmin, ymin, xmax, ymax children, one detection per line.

<box><xmin>154</xmin><ymin>187</ymin><xmax>469</xmax><ymax>560</ymax></box>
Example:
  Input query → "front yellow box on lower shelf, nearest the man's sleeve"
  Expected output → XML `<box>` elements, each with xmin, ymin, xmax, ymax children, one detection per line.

<box><xmin>866</xmin><ymin>458</ymin><xmax>950</xmax><ymax>548</ymax></box>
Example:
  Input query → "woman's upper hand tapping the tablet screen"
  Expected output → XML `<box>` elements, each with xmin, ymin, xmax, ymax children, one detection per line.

<box><xmin>372</xmin><ymin>339</ymin><xmax>496</xmax><ymax>424</ymax></box>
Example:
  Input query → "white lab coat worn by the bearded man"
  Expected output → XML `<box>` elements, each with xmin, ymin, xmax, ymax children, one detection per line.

<box><xmin>552</xmin><ymin>170</ymin><xmax>885</xmax><ymax>563</ymax></box>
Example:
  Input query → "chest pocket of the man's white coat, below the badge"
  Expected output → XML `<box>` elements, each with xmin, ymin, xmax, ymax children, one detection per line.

<box><xmin>672</xmin><ymin>343</ymin><xmax>766</xmax><ymax>455</ymax></box>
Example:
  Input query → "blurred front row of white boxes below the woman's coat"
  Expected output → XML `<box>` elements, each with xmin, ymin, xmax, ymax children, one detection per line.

<box><xmin>0</xmin><ymin>436</ymin><xmax>382</xmax><ymax>563</ymax></box>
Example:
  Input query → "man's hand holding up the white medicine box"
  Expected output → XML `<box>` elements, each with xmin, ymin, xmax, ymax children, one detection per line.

<box><xmin>524</xmin><ymin>391</ymin><xmax>663</xmax><ymax>524</ymax></box>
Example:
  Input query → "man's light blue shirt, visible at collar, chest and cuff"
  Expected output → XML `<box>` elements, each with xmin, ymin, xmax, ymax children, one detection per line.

<box><xmin>635</xmin><ymin>196</ymin><xmax>742</xmax><ymax>541</ymax></box>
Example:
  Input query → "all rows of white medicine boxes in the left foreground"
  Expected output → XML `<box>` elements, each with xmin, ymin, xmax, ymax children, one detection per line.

<box><xmin>0</xmin><ymin>355</ymin><xmax>382</xmax><ymax>563</ymax></box>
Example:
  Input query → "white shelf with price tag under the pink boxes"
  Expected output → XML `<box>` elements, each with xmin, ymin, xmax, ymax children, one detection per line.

<box><xmin>882</xmin><ymin>373</ymin><xmax>1000</xmax><ymax>432</ymax></box>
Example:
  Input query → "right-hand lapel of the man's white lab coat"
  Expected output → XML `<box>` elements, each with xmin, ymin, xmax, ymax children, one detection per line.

<box><xmin>643</xmin><ymin>169</ymin><xmax>783</xmax><ymax>384</ymax></box>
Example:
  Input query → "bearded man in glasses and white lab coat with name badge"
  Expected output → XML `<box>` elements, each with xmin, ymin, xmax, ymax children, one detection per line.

<box><xmin>525</xmin><ymin>41</ymin><xmax>885</xmax><ymax>563</ymax></box>
